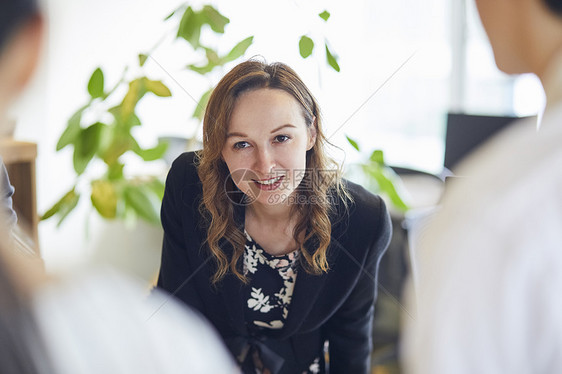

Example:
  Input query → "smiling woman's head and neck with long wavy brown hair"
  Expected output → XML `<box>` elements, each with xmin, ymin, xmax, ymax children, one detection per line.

<box><xmin>198</xmin><ymin>61</ymin><xmax>340</xmax><ymax>281</ymax></box>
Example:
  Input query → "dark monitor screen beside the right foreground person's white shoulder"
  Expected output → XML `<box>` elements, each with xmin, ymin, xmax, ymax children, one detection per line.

<box><xmin>444</xmin><ymin>113</ymin><xmax>519</xmax><ymax>169</ymax></box>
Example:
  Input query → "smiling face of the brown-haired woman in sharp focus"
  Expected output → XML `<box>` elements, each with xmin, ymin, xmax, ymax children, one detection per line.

<box><xmin>222</xmin><ymin>88</ymin><xmax>316</xmax><ymax>209</ymax></box>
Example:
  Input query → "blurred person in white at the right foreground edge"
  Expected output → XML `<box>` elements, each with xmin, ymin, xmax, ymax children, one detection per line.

<box><xmin>403</xmin><ymin>0</ymin><xmax>562</xmax><ymax>374</ymax></box>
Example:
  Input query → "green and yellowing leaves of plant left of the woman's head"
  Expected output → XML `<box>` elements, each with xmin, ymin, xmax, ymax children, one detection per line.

<box><xmin>41</xmin><ymin>4</ymin><xmax>253</xmax><ymax>225</ymax></box>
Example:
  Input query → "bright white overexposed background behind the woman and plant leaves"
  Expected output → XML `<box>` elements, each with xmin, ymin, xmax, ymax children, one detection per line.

<box><xmin>7</xmin><ymin>0</ymin><xmax>543</xmax><ymax>269</ymax></box>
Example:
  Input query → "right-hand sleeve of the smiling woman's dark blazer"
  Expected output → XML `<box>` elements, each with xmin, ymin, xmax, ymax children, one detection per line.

<box><xmin>325</xmin><ymin>197</ymin><xmax>392</xmax><ymax>374</ymax></box>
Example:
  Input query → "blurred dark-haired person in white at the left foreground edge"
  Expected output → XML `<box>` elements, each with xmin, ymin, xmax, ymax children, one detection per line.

<box><xmin>0</xmin><ymin>0</ymin><xmax>237</xmax><ymax>374</ymax></box>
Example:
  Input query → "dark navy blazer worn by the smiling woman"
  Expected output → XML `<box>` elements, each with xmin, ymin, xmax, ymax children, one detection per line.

<box><xmin>158</xmin><ymin>152</ymin><xmax>391</xmax><ymax>373</ymax></box>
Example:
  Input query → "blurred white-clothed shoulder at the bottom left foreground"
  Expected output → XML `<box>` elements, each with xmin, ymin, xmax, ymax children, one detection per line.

<box><xmin>34</xmin><ymin>269</ymin><xmax>237</xmax><ymax>373</ymax></box>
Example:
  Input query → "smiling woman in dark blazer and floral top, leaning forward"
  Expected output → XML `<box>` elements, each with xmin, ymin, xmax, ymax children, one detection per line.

<box><xmin>154</xmin><ymin>60</ymin><xmax>391</xmax><ymax>373</ymax></box>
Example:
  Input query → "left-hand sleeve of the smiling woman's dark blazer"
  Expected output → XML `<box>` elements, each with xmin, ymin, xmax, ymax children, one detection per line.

<box><xmin>157</xmin><ymin>153</ymin><xmax>204</xmax><ymax>312</ymax></box>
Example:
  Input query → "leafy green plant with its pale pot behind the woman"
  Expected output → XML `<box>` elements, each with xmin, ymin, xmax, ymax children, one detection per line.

<box><xmin>41</xmin><ymin>3</ymin><xmax>350</xmax><ymax>279</ymax></box>
